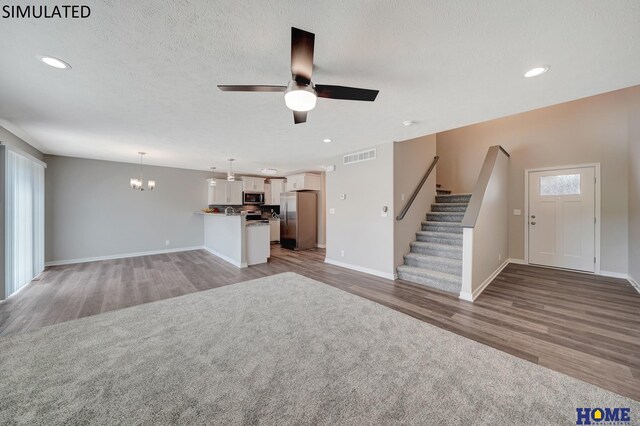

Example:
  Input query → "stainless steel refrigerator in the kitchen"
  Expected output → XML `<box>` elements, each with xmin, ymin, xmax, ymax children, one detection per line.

<box><xmin>280</xmin><ymin>191</ymin><xmax>318</xmax><ymax>250</ymax></box>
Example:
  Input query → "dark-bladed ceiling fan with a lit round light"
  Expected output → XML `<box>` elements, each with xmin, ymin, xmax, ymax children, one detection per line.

<box><xmin>218</xmin><ymin>27</ymin><xmax>378</xmax><ymax>124</ymax></box>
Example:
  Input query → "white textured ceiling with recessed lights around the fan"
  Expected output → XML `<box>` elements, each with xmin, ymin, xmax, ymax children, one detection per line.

<box><xmin>0</xmin><ymin>0</ymin><xmax>640</xmax><ymax>173</ymax></box>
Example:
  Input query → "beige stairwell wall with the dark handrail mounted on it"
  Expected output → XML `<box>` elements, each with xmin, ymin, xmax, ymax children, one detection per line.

<box><xmin>393</xmin><ymin>135</ymin><xmax>436</xmax><ymax>266</ymax></box>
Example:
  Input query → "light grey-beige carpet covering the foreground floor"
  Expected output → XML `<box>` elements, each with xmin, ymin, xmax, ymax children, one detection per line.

<box><xmin>0</xmin><ymin>273</ymin><xmax>640</xmax><ymax>425</ymax></box>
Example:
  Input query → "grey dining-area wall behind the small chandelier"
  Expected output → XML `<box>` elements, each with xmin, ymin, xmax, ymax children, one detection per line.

<box><xmin>45</xmin><ymin>155</ymin><xmax>209</xmax><ymax>263</ymax></box>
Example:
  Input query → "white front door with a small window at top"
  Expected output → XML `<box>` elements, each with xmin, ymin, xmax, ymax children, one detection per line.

<box><xmin>528</xmin><ymin>166</ymin><xmax>596</xmax><ymax>272</ymax></box>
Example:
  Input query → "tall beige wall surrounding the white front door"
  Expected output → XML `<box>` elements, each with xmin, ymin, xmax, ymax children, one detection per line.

<box><xmin>437</xmin><ymin>89</ymin><xmax>638</xmax><ymax>274</ymax></box>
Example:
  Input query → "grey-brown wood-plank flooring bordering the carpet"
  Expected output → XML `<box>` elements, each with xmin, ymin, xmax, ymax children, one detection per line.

<box><xmin>0</xmin><ymin>246</ymin><xmax>640</xmax><ymax>400</ymax></box>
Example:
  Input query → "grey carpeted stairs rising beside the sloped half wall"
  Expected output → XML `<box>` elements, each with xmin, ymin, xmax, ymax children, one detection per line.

<box><xmin>398</xmin><ymin>185</ymin><xmax>471</xmax><ymax>295</ymax></box>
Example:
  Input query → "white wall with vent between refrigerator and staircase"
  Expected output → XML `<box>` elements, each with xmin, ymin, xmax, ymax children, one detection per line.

<box><xmin>326</xmin><ymin>142</ymin><xmax>395</xmax><ymax>278</ymax></box>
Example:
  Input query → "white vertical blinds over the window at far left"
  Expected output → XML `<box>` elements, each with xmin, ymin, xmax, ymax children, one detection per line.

<box><xmin>5</xmin><ymin>150</ymin><xmax>44</xmax><ymax>297</ymax></box>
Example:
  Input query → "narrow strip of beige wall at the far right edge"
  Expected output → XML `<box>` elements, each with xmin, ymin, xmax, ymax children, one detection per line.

<box><xmin>628</xmin><ymin>86</ymin><xmax>640</xmax><ymax>283</ymax></box>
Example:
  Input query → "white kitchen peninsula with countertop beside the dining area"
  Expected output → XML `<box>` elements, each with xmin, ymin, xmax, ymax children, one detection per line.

<box><xmin>197</xmin><ymin>212</ymin><xmax>270</xmax><ymax>268</ymax></box>
